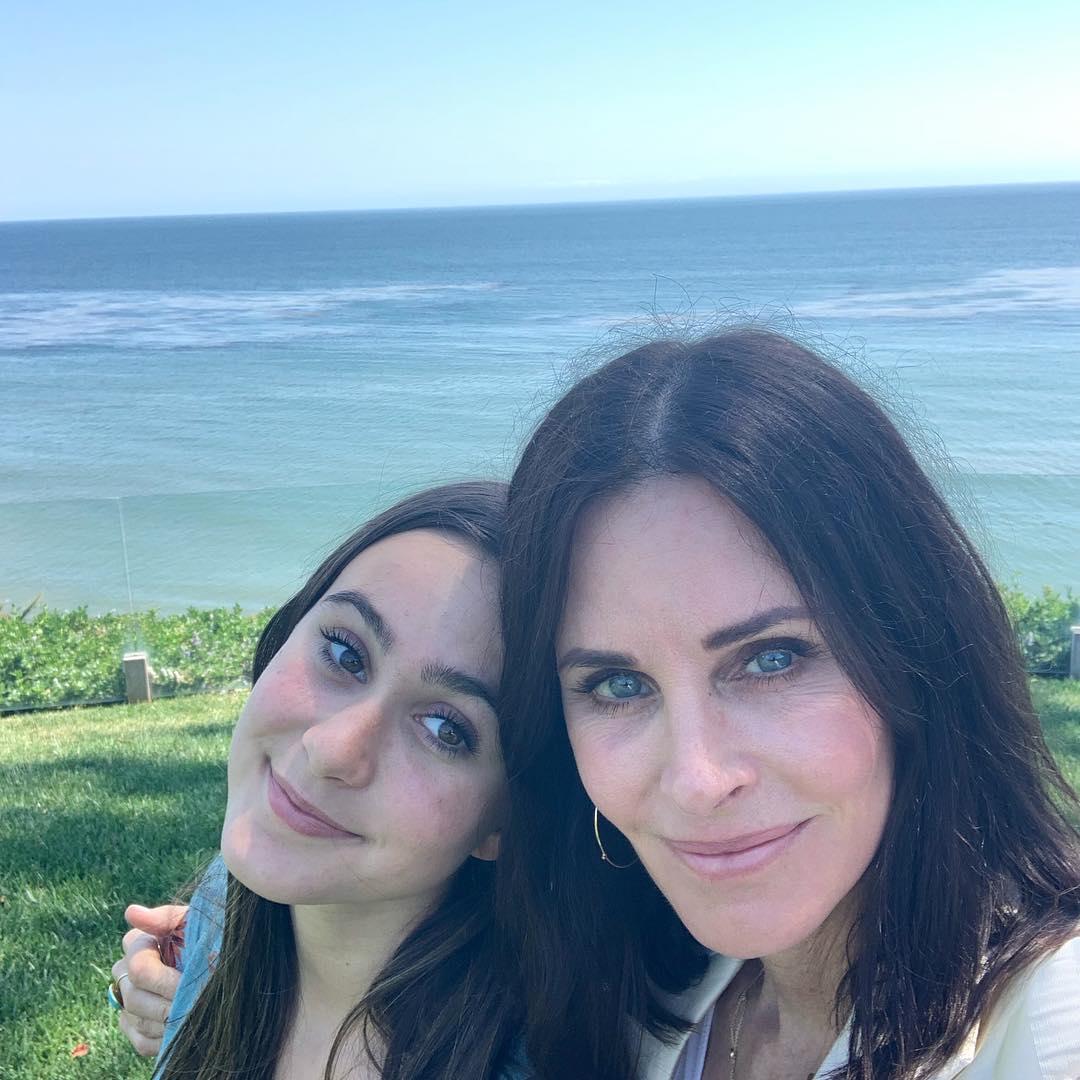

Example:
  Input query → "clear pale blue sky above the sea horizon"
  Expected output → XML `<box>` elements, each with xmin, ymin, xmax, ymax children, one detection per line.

<box><xmin>0</xmin><ymin>0</ymin><xmax>1080</xmax><ymax>219</ymax></box>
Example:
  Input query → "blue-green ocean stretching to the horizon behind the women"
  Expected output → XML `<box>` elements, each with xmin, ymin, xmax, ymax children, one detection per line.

<box><xmin>0</xmin><ymin>185</ymin><xmax>1080</xmax><ymax>611</ymax></box>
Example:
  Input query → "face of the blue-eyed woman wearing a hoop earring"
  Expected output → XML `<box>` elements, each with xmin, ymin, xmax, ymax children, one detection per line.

<box><xmin>557</xmin><ymin>477</ymin><xmax>892</xmax><ymax>957</ymax></box>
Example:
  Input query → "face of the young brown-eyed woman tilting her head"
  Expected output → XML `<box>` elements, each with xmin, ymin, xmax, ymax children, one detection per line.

<box><xmin>221</xmin><ymin>530</ymin><xmax>504</xmax><ymax>904</ymax></box>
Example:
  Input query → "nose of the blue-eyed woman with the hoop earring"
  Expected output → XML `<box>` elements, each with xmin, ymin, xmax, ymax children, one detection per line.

<box><xmin>660</xmin><ymin>692</ymin><xmax>757</xmax><ymax>816</ymax></box>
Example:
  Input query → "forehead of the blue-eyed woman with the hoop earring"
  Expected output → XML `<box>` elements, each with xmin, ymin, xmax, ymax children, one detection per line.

<box><xmin>562</xmin><ymin>476</ymin><xmax>799</xmax><ymax>636</ymax></box>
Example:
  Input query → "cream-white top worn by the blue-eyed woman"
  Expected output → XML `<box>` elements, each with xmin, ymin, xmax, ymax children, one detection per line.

<box><xmin>640</xmin><ymin>937</ymin><xmax>1080</xmax><ymax>1080</ymax></box>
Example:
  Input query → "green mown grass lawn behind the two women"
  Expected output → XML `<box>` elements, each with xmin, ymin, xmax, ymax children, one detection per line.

<box><xmin>0</xmin><ymin>680</ymin><xmax>1080</xmax><ymax>1080</ymax></box>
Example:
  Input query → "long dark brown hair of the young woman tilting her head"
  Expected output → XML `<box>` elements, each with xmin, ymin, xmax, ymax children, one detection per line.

<box><xmin>159</xmin><ymin>482</ymin><xmax>522</xmax><ymax>1080</ymax></box>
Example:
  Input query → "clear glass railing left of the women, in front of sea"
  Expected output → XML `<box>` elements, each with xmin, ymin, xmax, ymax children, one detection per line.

<box><xmin>0</xmin><ymin>477</ymin><xmax>468</xmax><ymax>712</ymax></box>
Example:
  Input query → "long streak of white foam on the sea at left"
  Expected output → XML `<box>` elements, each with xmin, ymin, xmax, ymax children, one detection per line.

<box><xmin>0</xmin><ymin>282</ymin><xmax>501</xmax><ymax>349</ymax></box>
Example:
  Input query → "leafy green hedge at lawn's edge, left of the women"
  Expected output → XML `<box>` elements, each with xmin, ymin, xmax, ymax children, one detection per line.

<box><xmin>0</xmin><ymin>606</ymin><xmax>272</xmax><ymax>708</ymax></box>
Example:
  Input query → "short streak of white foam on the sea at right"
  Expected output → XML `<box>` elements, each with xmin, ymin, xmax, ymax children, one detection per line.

<box><xmin>793</xmin><ymin>266</ymin><xmax>1080</xmax><ymax>319</ymax></box>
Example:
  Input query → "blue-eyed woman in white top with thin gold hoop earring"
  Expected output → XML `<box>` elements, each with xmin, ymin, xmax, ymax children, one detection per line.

<box><xmin>500</xmin><ymin>330</ymin><xmax>1080</xmax><ymax>1080</ymax></box>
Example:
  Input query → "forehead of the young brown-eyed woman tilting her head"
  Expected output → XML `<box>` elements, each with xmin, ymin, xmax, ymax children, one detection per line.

<box><xmin>327</xmin><ymin>529</ymin><xmax>500</xmax><ymax>669</ymax></box>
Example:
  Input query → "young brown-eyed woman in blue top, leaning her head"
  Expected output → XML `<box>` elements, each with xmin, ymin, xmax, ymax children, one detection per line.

<box><xmin>120</xmin><ymin>484</ymin><xmax>521</xmax><ymax>1080</ymax></box>
